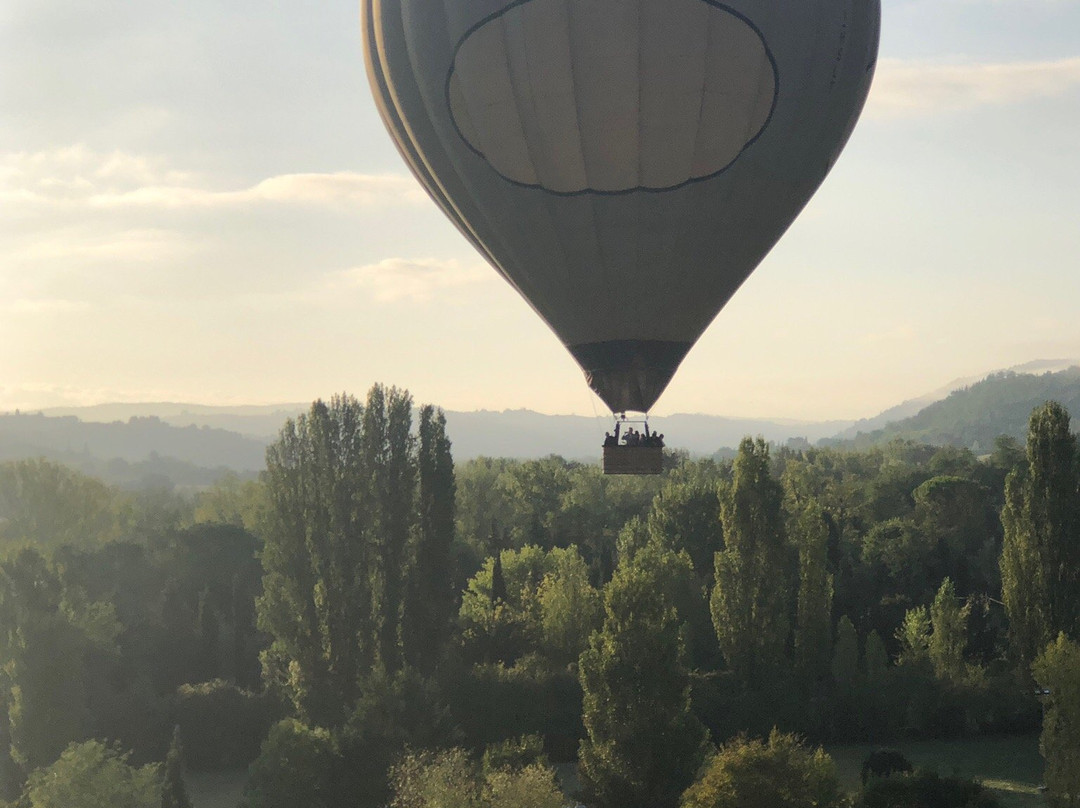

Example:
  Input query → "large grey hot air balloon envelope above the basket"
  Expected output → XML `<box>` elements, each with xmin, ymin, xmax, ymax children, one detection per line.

<box><xmin>361</xmin><ymin>0</ymin><xmax>880</xmax><ymax>413</ymax></box>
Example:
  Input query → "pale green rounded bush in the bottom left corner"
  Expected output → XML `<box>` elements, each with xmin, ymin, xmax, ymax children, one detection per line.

<box><xmin>25</xmin><ymin>741</ymin><xmax>162</xmax><ymax>808</ymax></box>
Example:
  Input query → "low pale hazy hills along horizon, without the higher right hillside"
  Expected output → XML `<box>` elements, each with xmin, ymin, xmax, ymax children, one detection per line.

<box><xmin>6</xmin><ymin>403</ymin><xmax>850</xmax><ymax>473</ymax></box>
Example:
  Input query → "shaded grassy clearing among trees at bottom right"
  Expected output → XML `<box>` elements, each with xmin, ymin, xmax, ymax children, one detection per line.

<box><xmin>826</xmin><ymin>735</ymin><xmax>1045</xmax><ymax>808</ymax></box>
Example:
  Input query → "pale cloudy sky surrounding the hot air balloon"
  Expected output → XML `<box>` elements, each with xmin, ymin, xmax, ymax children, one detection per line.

<box><xmin>0</xmin><ymin>0</ymin><xmax>1080</xmax><ymax>420</ymax></box>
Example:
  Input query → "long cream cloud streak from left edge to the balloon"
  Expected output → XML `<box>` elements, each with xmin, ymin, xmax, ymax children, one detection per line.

<box><xmin>0</xmin><ymin>145</ymin><xmax>427</xmax><ymax>210</ymax></box>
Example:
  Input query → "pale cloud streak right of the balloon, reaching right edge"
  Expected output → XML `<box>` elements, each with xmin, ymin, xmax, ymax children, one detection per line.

<box><xmin>866</xmin><ymin>57</ymin><xmax>1080</xmax><ymax>119</ymax></box>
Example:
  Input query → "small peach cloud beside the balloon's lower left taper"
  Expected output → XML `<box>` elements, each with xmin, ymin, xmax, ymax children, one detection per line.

<box><xmin>335</xmin><ymin>258</ymin><xmax>496</xmax><ymax>302</ymax></box>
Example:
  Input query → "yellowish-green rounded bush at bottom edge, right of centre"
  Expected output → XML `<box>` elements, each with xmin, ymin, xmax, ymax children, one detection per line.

<box><xmin>679</xmin><ymin>729</ymin><xmax>848</xmax><ymax>808</ymax></box>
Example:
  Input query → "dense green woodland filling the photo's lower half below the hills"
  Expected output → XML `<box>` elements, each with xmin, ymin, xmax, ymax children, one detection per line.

<box><xmin>0</xmin><ymin>386</ymin><xmax>1080</xmax><ymax>808</ymax></box>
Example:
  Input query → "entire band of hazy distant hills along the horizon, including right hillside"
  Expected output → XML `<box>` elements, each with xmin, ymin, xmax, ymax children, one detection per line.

<box><xmin>12</xmin><ymin>361</ymin><xmax>1080</xmax><ymax>487</ymax></box>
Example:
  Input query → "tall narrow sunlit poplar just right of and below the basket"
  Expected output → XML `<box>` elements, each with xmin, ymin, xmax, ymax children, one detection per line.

<box><xmin>710</xmin><ymin>437</ymin><xmax>791</xmax><ymax>685</ymax></box>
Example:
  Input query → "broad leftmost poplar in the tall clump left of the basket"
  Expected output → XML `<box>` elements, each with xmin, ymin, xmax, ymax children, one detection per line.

<box><xmin>258</xmin><ymin>396</ymin><xmax>377</xmax><ymax>725</ymax></box>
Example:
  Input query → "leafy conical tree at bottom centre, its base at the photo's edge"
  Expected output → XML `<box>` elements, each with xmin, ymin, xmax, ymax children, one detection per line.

<box><xmin>579</xmin><ymin>542</ymin><xmax>706</xmax><ymax>808</ymax></box>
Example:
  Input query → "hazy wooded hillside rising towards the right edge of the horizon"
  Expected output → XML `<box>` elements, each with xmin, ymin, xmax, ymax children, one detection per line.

<box><xmin>827</xmin><ymin>366</ymin><xmax>1080</xmax><ymax>452</ymax></box>
